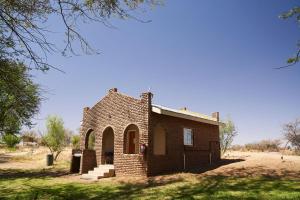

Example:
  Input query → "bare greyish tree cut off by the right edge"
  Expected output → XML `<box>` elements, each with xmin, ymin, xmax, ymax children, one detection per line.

<box><xmin>283</xmin><ymin>119</ymin><xmax>300</xmax><ymax>151</ymax></box>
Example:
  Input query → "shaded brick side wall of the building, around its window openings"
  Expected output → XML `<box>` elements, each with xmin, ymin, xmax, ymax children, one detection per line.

<box><xmin>148</xmin><ymin>113</ymin><xmax>220</xmax><ymax>175</ymax></box>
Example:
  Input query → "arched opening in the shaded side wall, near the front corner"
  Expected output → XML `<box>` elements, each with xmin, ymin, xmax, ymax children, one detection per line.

<box><xmin>153</xmin><ymin>125</ymin><xmax>166</xmax><ymax>155</ymax></box>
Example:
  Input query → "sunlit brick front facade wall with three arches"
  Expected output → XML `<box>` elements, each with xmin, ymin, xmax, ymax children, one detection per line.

<box><xmin>80</xmin><ymin>89</ymin><xmax>151</xmax><ymax>176</ymax></box>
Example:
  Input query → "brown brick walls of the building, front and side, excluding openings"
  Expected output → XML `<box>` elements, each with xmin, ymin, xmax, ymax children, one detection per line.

<box><xmin>80</xmin><ymin>88</ymin><xmax>220</xmax><ymax>176</ymax></box>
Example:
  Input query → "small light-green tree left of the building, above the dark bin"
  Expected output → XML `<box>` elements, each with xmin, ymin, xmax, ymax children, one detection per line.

<box><xmin>42</xmin><ymin>116</ymin><xmax>66</xmax><ymax>161</ymax></box>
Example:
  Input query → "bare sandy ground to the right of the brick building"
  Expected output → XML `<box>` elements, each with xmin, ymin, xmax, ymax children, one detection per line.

<box><xmin>205</xmin><ymin>151</ymin><xmax>300</xmax><ymax>178</ymax></box>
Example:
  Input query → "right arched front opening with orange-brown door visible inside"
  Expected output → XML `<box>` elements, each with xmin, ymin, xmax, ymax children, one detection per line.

<box><xmin>124</xmin><ymin>124</ymin><xmax>140</xmax><ymax>154</ymax></box>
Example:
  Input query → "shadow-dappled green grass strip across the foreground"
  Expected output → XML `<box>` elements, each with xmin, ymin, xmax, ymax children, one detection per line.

<box><xmin>0</xmin><ymin>170</ymin><xmax>300</xmax><ymax>199</ymax></box>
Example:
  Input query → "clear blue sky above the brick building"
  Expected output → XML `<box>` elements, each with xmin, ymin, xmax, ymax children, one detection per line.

<box><xmin>29</xmin><ymin>0</ymin><xmax>300</xmax><ymax>144</ymax></box>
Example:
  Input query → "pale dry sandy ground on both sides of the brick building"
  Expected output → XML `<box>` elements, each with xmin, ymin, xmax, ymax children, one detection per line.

<box><xmin>0</xmin><ymin>147</ymin><xmax>300</xmax><ymax>182</ymax></box>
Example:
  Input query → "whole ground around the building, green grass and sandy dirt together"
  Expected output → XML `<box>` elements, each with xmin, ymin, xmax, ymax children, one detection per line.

<box><xmin>0</xmin><ymin>148</ymin><xmax>300</xmax><ymax>200</ymax></box>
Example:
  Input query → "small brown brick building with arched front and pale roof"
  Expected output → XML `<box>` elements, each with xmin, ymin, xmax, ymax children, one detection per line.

<box><xmin>80</xmin><ymin>88</ymin><xmax>220</xmax><ymax>176</ymax></box>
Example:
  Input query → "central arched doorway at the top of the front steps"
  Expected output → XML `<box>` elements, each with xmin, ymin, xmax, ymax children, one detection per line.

<box><xmin>101</xmin><ymin>127</ymin><xmax>114</xmax><ymax>164</ymax></box>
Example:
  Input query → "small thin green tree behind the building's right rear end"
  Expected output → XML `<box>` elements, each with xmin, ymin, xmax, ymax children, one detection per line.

<box><xmin>220</xmin><ymin>119</ymin><xmax>237</xmax><ymax>154</ymax></box>
